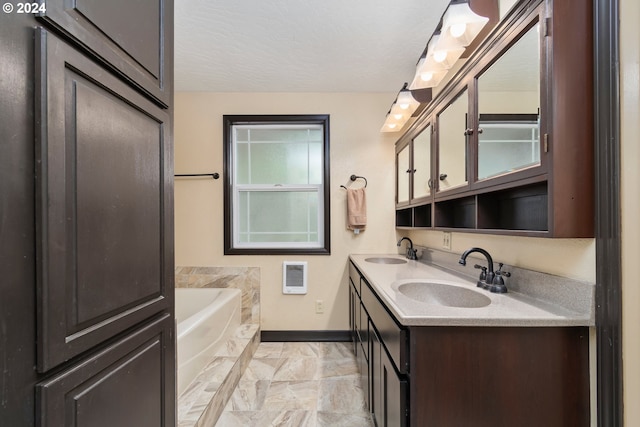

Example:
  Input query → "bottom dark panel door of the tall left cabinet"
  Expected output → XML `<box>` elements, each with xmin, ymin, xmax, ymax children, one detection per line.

<box><xmin>36</xmin><ymin>314</ymin><xmax>175</xmax><ymax>427</ymax></box>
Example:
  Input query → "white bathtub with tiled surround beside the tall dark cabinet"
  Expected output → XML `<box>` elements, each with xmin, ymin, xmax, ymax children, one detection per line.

<box><xmin>176</xmin><ymin>288</ymin><xmax>242</xmax><ymax>395</ymax></box>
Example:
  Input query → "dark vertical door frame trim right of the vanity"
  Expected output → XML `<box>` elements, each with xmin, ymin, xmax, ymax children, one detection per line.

<box><xmin>594</xmin><ymin>0</ymin><xmax>623</xmax><ymax>427</ymax></box>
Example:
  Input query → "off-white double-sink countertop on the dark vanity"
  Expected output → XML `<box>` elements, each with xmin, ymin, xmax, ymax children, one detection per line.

<box><xmin>350</xmin><ymin>254</ymin><xmax>594</xmax><ymax>327</ymax></box>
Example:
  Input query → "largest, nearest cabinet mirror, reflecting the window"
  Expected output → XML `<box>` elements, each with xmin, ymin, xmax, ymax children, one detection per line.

<box><xmin>478</xmin><ymin>24</ymin><xmax>540</xmax><ymax>180</ymax></box>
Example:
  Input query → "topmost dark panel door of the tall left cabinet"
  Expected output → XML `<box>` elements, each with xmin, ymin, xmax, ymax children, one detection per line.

<box><xmin>41</xmin><ymin>0</ymin><xmax>173</xmax><ymax>107</ymax></box>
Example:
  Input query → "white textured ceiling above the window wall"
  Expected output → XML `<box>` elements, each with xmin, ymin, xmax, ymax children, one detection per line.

<box><xmin>175</xmin><ymin>0</ymin><xmax>448</xmax><ymax>92</ymax></box>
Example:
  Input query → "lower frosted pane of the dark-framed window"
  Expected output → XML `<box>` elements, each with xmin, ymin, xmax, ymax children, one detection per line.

<box><xmin>238</xmin><ymin>191</ymin><xmax>319</xmax><ymax>243</ymax></box>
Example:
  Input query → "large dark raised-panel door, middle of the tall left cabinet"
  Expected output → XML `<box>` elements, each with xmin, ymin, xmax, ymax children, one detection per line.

<box><xmin>36</xmin><ymin>30</ymin><xmax>174</xmax><ymax>372</ymax></box>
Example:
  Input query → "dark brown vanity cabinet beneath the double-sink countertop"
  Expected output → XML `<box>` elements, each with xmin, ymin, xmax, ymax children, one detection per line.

<box><xmin>349</xmin><ymin>262</ymin><xmax>590</xmax><ymax>427</ymax></box>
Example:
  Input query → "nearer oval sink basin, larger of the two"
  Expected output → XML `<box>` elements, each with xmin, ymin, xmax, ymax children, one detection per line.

<box><xmin>396</xmin><ymin>281</ymin><xmax>491</xmax><ymax>308</ymax></box>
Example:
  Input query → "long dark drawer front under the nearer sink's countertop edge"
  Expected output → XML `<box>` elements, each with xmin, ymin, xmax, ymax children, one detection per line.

<box><xmin>360</xmin><ymin>279</ymin><xmax>409</xmax><ymax>374</ymax></box>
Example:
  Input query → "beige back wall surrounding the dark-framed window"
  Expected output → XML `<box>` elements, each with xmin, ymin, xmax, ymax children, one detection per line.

<box><xmin>175</xmin><ymin>93</ymin><xmax>397</xmax><ymax>330</ymax></box>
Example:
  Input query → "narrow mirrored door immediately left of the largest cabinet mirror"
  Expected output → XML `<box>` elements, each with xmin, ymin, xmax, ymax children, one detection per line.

<box><xmin>438</xmin><ymin>89</ymin><xmax>469</xmax><ymax>191</ymax></box>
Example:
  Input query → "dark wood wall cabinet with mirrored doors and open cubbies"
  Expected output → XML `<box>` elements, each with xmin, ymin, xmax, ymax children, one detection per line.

<box><xmin>396</xmin><ymin>0</ymin><xmax>594</xmax><ymax>237</ymax></box>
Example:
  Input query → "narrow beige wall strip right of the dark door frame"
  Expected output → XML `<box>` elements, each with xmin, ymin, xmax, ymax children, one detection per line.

<box><xmin>620</xmin><ymin>0</ymin><xmax>640</xmax><ymax>426</ymax></box>
